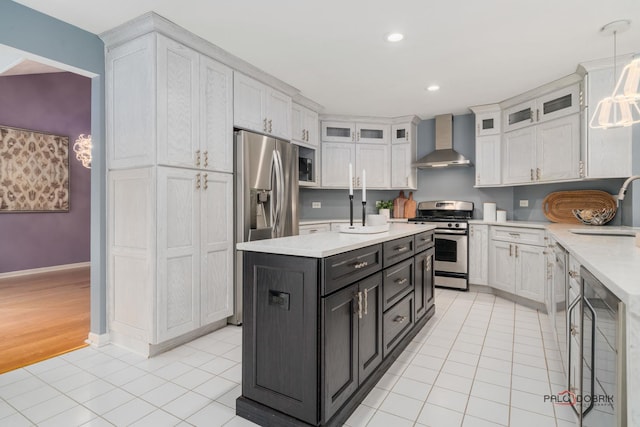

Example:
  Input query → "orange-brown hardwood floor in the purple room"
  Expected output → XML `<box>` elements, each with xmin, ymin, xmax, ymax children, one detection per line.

<box><xmin>0</xmin><ymin>267</ymin><xmax>90</xmax><ymax>373</ymax></box>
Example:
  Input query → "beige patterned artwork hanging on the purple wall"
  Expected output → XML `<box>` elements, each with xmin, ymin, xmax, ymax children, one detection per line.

<box><xmin>0</xmin><ymin>126</ymin><xmax>69</xmax><ymax>213</ymax></box>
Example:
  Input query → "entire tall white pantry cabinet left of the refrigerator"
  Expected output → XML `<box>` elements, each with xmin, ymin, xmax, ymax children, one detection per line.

<box><xmin>105</xmin><ymin>31</ymin><xmax>233</xmax><ymax>356</ymax></box>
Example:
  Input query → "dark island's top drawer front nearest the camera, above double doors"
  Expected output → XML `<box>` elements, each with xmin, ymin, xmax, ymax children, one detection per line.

<box><xmin>322</xmin><ymin>245</ymin><xmax>382</xmax><ymax>295</ymax></box>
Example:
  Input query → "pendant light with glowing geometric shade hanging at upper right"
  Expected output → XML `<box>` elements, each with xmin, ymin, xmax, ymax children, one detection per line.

<box><xmin>589</xmin><ymin>20</ymin><xmax>640</xmax><ymax>129</ymax></box>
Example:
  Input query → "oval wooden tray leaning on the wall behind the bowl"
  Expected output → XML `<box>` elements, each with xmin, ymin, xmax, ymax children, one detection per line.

<box><xmin>542</xmin><ymin>190</ymin><xmax>616</xmax><ymax>224</ymax></box>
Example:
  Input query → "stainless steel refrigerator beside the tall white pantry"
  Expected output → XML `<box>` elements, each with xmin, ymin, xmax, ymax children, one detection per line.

<box><xmin>229</xmin><ymin>130</ymin><xmax>298</xmax><ymax>325</ymax></box>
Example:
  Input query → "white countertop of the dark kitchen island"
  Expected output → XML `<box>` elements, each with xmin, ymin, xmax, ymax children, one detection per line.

<box><xmin>236</xmin><ymin>223</ymin><xmax>435</xmax><ymax>258</ymax></box>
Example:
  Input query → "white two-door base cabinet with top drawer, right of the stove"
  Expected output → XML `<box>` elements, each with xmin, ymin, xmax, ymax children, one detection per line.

<box><xmin>489</xmin><ymin>227</ymin><xmax>547</xmax><ymax>303</ymax></box>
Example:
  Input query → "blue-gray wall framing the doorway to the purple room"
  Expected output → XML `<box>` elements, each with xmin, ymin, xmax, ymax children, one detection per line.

<box><xmin>0</xmin><ymin>0</ymin><xmax>107</xmax><ymax>334</ymax></box>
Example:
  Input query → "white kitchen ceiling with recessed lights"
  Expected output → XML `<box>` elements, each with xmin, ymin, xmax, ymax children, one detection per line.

<box><xmin>11</xmin><ymin>0</ymin><xmax>640</xmax><ymax>119</ymax></box>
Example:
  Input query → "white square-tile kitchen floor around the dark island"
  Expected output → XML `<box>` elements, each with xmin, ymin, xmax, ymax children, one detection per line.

<box><xmin>0</xmin><ymin>289</ymin><xmax>574</xmax><ymax>427</ymax></box>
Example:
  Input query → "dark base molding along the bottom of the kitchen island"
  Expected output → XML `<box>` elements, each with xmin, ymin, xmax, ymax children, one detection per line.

<box><xmin>236</xmin><ymin>305</ymin><xmax>436</xmax><ymax>427</ymax></box>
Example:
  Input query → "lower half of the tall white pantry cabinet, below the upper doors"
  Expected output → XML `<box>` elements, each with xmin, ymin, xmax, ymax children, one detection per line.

<box><xmin>109</xmin><ymin>167</ymin><xmax>233</xmax><ymax>355</ymax></box>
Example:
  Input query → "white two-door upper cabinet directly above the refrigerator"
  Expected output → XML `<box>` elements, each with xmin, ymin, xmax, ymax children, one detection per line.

<box><xmin>233</xmin><ymin>72</ymin><xmax>291</xmax><ymax>140</ymax></box>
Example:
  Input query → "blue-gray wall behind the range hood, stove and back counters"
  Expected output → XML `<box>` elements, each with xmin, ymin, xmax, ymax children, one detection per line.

<box><xmin>300</xmin><ymin>114</ymin><xmax>640</xmax><ymax>226</ymax></box>
